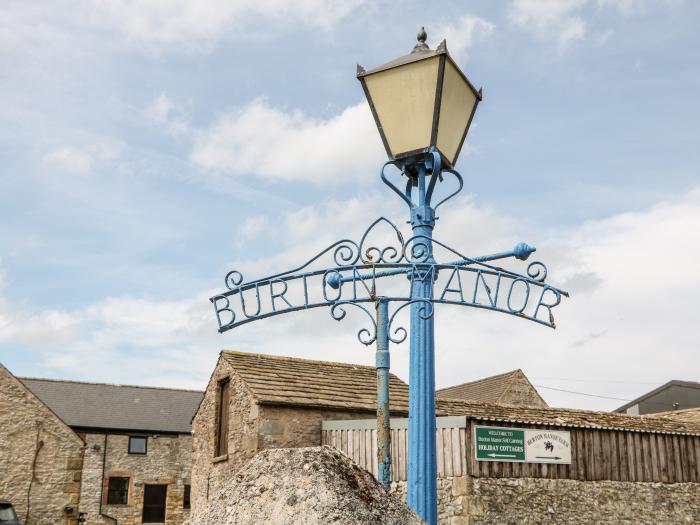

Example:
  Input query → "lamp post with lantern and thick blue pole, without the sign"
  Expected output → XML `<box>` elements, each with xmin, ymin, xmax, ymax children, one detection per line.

<box><xmin>357</xmin><ymin>28</ymin><xmax>481</xmax><ymax>525</ymax></box>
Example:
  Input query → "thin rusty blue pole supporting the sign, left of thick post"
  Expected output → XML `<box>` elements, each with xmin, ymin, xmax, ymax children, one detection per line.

<box><xmin>376</xmin><ymin>297</ymin><xmax>391</xmax><ymax>490</ymax></box>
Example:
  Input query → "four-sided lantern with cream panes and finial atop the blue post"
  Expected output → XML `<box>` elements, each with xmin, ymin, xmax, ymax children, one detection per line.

<box><xmin>357</xmin><ymin>28</ymin><xmax>481</xmax><ymax>167</ymax></box>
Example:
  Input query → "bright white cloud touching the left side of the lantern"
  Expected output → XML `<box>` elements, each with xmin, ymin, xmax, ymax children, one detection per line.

<box><xmin>190</xmin><ymin>98</ymin><xmax>385</xmax><ymax>183</ymax></box>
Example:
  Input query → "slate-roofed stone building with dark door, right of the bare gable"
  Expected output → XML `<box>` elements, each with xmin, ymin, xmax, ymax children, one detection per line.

<box><xmin>21</xmin><ymin>378</ymin><xmax>202</xmax><ymax>525</ymax></box>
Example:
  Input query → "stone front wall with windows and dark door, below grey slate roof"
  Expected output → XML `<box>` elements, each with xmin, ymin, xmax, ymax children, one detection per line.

<box><xmin>80</xmin><ymin>434</ymin><xmax>192</xmax><ymax>525</ymax></box>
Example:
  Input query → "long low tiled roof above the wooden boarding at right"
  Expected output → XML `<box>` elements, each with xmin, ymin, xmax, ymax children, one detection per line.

<box><xmin>437</xmin><ymin>399</ymin><xmax>700</xmax><ymax>435</ymax></box>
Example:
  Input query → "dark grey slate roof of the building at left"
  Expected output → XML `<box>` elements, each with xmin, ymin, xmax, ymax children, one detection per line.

<box><xmin>18</xmin><ymin>377</ymin><xmax>203</xmax><ymax>434</ymax></box>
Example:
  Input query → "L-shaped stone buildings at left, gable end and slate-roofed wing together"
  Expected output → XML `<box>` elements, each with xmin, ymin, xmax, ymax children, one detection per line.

<box><xmin>0</xmin><ymin>362</ymin><xmax>202</xmax><ymax>525</ymax></box>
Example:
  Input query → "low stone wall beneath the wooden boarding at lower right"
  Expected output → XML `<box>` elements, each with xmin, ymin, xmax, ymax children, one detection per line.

<box><xmin>392</xmin><ymin>476</ymin><xmax>700</xmax><ymax>525</ymax></box>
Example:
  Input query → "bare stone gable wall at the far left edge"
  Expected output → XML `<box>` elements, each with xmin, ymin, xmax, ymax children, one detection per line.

<box><xmin>0</xmin><ymin>365</ymin><xmax>84</xmax><ymax>525</ymax></box>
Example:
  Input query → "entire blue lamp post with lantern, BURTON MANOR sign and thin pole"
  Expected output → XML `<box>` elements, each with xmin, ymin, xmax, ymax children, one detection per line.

<box><xmin>210</xmin><ymin>25</ymin><xmax>568</xmax><ymax>525</ymax></box>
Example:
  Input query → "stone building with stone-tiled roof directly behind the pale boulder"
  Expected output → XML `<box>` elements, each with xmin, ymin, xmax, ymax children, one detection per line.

<box><xmin>192</xmin><ymin>350</ymin><xmax>408</xmax><ymax>523</ymax></box>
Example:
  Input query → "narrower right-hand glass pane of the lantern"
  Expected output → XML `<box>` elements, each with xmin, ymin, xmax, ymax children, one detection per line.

<box><xmin>436</xmin><ymin>59</ymin><xmax>477</xmax><ymax>166</ymax></box>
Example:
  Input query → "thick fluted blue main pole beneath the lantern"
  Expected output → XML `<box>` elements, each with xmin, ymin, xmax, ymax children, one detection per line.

<box><xmin>408</xmin><ymin>163</ymin><xmax>437</xmax><ymax>525</ymax></box>
